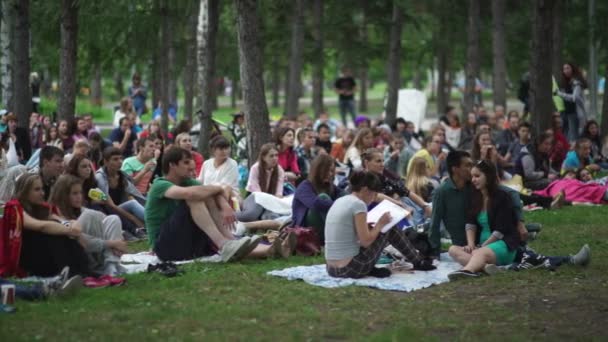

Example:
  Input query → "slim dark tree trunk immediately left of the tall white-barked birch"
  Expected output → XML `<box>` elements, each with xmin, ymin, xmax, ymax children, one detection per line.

<box><xmin>182</xmin><ymin>1</ymin><xmax>200</xmax><ymax>120</ymax></box>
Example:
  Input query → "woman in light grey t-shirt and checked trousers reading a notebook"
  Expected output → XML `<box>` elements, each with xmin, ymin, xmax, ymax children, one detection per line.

<box><xmin>325</xmin><ymin>170</ymin><xmax>435</xmax><ymax>278</ymax></box>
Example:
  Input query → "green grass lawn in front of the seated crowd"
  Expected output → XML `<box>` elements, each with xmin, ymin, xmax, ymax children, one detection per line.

<box><xmin>0</xmin><ymin>203</ymin><xmax>608</xmax><ymax>341</ymax></box>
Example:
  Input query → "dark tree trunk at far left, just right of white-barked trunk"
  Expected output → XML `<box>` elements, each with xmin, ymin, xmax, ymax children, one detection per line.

<box><xmin>13</xmin><ymin>0</ymin><xmax>32</xmax><ymax>128</ymax></box>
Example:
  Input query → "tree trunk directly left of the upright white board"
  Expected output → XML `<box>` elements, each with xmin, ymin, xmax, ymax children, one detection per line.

<box><xmin>385</xmin><ymin>0</ymin><xmax>403</xmax><ymax>124</ymax></box>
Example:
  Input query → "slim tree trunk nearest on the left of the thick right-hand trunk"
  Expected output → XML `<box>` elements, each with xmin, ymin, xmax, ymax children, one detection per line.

<box><xmin>492</xmin><ymin>0</ymin><xmax>507</xmax><ymax>108</ymax></box>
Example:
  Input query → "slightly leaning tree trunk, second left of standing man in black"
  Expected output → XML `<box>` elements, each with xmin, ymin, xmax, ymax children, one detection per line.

<box><xmin>285</xmin><ymin>0</ymin><xmax>306</xmax><ymax>117</ymax></box>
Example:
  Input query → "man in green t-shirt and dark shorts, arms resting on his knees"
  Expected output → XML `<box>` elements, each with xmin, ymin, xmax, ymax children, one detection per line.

<box><xmin>145</xmin><ymin>147</ymin><xmax>259</xmax><ymax>262</ymax></box>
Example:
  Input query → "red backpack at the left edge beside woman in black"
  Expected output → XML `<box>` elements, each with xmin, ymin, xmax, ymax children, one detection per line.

<box><xmin>0</xmin><ymin>199</ymin><xmax>26</xmax><ymax>277</ymax></box>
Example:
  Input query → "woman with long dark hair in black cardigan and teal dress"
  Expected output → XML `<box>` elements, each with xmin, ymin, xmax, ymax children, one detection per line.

<box><xmin>448</xmin><ymin>160</ymin><xmax>521</xmax><ymax>280</ymax></box>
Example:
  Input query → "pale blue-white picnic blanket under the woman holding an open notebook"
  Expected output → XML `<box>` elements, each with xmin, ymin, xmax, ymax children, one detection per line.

<box><xmin>268</xmin><ymin>253</ymin><xmax>461</xmax><ymax>292</ymax></box>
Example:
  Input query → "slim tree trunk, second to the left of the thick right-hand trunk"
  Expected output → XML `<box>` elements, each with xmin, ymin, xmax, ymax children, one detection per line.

<box><xmin>464</xmin><ymin>0</ymin><xmax>481</xmax><ymax>113</ymax></box>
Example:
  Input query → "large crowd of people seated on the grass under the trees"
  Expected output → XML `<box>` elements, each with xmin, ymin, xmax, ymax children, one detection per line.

<box><xmin>0</xmin><ymin>69</ymin><xmax>596</xmax><ymax>300</ymax></box>
